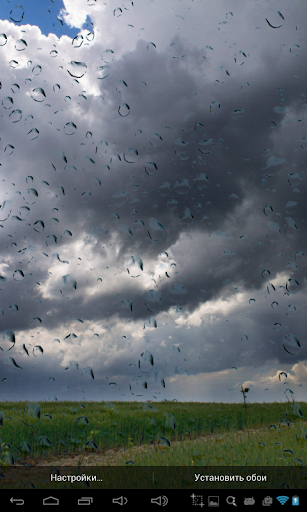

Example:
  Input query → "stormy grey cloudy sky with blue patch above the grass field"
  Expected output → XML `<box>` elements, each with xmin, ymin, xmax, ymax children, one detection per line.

<box><xmin>0</xmin><ymin>0</ymin><xmax>307</xmax><ymax>403</ymax></box>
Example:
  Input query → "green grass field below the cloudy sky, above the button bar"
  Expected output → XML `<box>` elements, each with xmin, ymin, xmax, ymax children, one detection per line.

<box><xmin>0</xmin><ymin>402</ymin><xmax>307</xmax><ymax>466</ymax></box>
